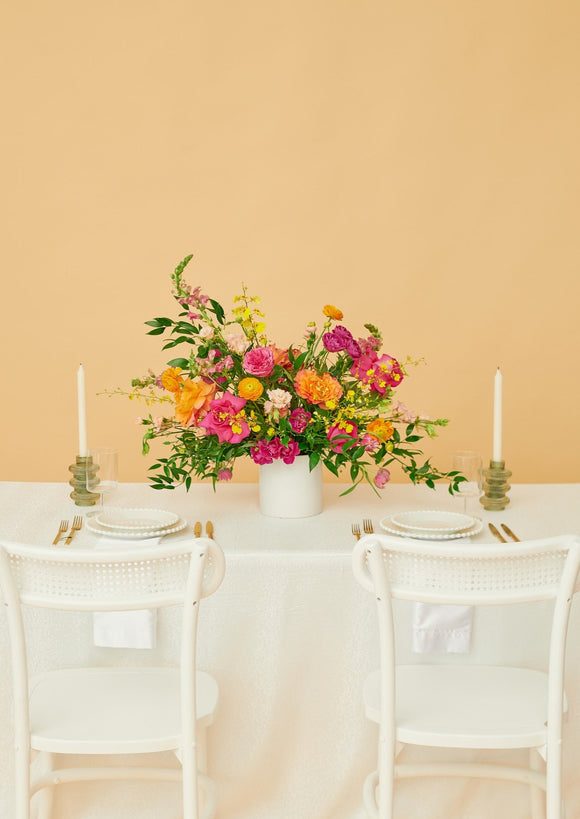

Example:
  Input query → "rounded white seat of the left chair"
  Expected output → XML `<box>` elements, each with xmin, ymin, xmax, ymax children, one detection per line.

<box><xmin>30</xmin><ymin>667</ymin><xmax>219</xmax><ymax>754</ymax></box>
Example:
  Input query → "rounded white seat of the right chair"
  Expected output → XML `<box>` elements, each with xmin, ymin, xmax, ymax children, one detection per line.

<box><xmin>363</xmin><ymin>665</ymin><xmax>566</xmax><ymax>748</ymax></box>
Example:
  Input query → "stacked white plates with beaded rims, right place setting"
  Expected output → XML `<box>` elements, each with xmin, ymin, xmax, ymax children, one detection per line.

<box><xmin>380</xmin><ymin>510</ymin><xmax>483</xmax><ymax>540</ymax></box>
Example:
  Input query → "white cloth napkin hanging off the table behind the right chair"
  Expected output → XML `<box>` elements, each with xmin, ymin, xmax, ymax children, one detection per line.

<box><xmin>411</xmin><ymin>538</ymin><xmax>473</xmax><ymax>654</ymax></box>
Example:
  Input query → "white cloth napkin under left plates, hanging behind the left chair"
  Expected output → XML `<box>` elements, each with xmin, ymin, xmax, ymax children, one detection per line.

<box><xmin>93</xmin><ymin>537</ymin><xmax>161</xmax><ymax>648</ymax></box>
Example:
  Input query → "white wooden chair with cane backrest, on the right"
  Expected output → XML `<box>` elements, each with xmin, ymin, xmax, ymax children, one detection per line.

<box><xmin>353</xmin><ymin>535</ymin><xmax>580</xmax><ymax>819</ymax></box>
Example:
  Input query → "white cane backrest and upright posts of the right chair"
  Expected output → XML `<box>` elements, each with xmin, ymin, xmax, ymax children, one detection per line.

<box><xmin>353</xmin><ymin>534</ymin><xmax>580</xmax><ymax>760</ymax></box>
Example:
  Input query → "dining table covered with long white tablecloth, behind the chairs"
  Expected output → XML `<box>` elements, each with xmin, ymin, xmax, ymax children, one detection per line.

<box><xmin>0</xmin><ymin>482</ymin><xmax>580</xmax><ymax>819</ymax></box>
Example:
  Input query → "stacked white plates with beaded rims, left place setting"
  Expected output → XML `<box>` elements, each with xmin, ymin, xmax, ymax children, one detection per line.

<box><xmin>86</xmin><ymin>507</ymin><xmax>187</xmax><ymax>540</ymax></box>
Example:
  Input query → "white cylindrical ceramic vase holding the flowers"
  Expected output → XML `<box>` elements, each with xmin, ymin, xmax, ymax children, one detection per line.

<box><xmin>259</xmin><ymin>455</ymin><xmax>322</xmax><ymax>518</ymax></box>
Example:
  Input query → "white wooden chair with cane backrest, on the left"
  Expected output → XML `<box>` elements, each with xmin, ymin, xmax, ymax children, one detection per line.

<box><xmin>0</xmin><ymin>538</ymin><xmax>224</xmax><ymax>819</ymax></box>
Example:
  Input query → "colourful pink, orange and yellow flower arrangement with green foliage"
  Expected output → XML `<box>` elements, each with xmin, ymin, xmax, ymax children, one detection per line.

<box><xmin>116</xmin><ymin>256</ymin><xmax>462</xmax><ymax>494</ymax></box>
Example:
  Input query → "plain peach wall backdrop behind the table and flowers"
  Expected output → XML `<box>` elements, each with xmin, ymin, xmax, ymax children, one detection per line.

<box><xmin>0</xmin><ymin>0</ymin><xmax>580</xmax><ymax>482</ymax></box>
